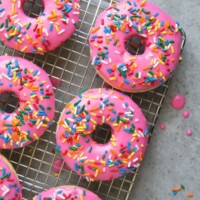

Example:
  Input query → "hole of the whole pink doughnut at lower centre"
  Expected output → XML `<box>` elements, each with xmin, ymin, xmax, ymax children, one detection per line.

<box><xmin>90</xmin><ymin>123</ymin><xmax>112</xmax><ymax>144</ymax></box>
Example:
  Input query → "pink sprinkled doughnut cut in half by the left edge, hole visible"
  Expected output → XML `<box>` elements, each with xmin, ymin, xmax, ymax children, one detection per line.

<box><xmin>0</xmin><ymin>56</ymin><xmax>55</xmax><ymax>149</ymax></box>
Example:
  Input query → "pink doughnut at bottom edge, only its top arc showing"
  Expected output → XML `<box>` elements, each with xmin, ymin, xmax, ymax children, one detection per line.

<box><xmin>33</xmin><ymin>185</ymin><xmax>100</xmax><ymax>200</ymax></box>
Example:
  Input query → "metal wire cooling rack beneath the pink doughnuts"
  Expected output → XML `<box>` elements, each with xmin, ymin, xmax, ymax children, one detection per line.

<box><xmin>0</xmin><ymin>0</ymin><xmax>185</xmax><ymax>200</ymax></box>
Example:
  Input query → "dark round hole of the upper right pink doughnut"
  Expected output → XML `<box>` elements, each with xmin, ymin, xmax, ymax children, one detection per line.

<box><xmin>125</xmin><ymin>35</ymin><xmax>146</xmax><ymax>55</ymax></box>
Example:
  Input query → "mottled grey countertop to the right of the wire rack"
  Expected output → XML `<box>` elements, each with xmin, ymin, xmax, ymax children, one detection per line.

<box><xmin>130</xmin><ymin>0</ymin><xmax>200</xmax><ymax>200</ymax></box>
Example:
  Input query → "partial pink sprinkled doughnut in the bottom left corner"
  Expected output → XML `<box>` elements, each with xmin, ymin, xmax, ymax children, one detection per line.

<box><xmin>0</xmin><ymin>154</ymin><xmax>22</xmax><ymax>200</ymax></box>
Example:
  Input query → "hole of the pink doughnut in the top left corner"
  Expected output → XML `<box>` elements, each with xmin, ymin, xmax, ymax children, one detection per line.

<box><xmin>22</xmin><ymin>0</ymin><xmax>44</xmax><ymax>18</ymax></box>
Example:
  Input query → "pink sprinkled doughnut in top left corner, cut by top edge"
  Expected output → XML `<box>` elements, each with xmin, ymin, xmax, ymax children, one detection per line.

<box><xmin>0</xmin><ymin>0</ymin><xmax>80</xmax><ymax>54</ymax></box>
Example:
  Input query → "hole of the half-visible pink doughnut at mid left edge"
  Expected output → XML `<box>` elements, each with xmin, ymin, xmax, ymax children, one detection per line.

<box><xmin>0</xmin><ymin>92</ymin><xmax>19</xmax><ymax>113</ymax></box>
